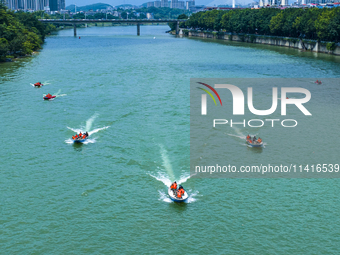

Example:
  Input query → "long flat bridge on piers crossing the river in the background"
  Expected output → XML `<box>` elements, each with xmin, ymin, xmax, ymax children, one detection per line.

<box><xmin>39</xmin><ymin>19</ymin><xmax>187</xmax><ymax>36</ymax></box>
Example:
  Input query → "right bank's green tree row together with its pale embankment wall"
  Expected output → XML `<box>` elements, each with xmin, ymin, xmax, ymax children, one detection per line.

<box><xmin>170</xmin><ymin>8</ymin><xmax>340</xmax><ymax>55</ymax></box>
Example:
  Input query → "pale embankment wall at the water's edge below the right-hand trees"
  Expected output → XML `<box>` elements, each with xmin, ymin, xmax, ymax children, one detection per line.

<box><xmin>178</xmin><ymin>29</ymin><xmax>340</xmax><ymax>56</ymax></box>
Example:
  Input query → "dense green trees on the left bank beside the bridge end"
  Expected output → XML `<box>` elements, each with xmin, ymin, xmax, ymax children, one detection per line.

<box><xmin>0</xmin><ymin>4</ymin><xmax>54</xmax><ymax>61</ymax></box>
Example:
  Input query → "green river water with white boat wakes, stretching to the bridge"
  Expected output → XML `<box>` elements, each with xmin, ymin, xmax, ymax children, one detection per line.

<box><xmin>0</xmin><ymin>26</ymin><xmax>340</xmax><ymax>254</ymax></box>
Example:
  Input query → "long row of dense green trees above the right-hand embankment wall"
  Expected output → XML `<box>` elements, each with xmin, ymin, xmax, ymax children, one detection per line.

<box><xmin>185</xmin><ymin>8</ymin><xmax>340</xmax><ymax>42</ymax></box>
